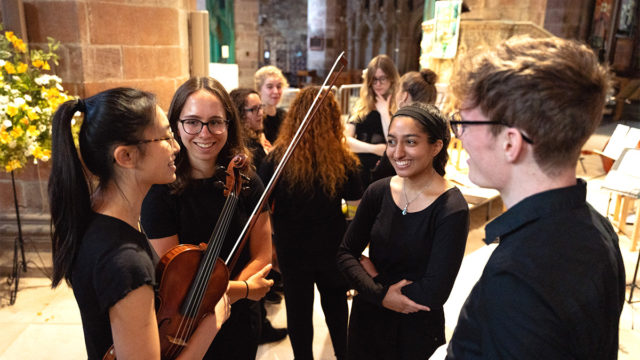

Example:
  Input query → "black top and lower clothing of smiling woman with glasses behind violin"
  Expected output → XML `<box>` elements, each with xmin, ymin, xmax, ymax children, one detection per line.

<box><xmin>140</xmin><ymin>174</ymin><xmax>264</xmax><ymax>359</ymax></box>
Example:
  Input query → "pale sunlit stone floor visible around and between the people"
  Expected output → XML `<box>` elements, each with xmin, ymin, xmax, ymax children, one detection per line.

<box><xmin>0</xmin><ymin>119</ymin><xmax>640</xmax><ymax>360</ymax></box>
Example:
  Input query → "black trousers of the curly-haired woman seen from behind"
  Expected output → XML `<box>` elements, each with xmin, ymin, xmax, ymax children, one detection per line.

<box><xmin>280</xmin><ymin>259</ymin><xmax>349</xmax><ymax>360</ymax></box>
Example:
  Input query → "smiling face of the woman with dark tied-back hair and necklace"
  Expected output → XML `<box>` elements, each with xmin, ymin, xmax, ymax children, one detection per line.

<box><xmin>387</xmin><ymin>116</ymin><xmax>442</xmax><ymax>178</ymax></box>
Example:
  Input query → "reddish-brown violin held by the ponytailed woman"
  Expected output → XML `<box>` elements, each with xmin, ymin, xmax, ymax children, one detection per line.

<box><xmin>103</xmin><ymin>155</ymin><xmax>248</xmax><ymax>360</ymax></box>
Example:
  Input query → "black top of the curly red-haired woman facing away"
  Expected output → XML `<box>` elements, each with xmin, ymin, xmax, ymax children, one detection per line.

<box><xmin>259</xmin><ymin>156</ymin><xmax>363</xmax><ymax>269</ymax></box>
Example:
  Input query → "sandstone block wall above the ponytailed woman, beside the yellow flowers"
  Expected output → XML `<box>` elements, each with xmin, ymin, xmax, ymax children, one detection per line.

<box><xmin>24</xmin><ymin>0</ymin><xmax>195</xmax><ymax>110</ymax></box>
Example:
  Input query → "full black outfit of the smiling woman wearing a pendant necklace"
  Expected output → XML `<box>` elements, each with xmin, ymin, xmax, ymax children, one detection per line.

<box><xmin>338</xmin><ymin>178</ymin><xmax>469</xmax><ymax>360</ymax></box>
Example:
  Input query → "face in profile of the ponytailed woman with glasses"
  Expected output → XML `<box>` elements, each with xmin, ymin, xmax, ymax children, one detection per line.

<box><xmin>138</xmin><ymin>106</ymin><xmax>180</xmax><ymax>184</ymax></box>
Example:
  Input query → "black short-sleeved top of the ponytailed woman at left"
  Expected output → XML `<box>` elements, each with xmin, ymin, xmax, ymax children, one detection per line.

<box><xmin>71</xmin><ymin>214</ymin><xmax>155</xmax><ymax>359</ymax></box>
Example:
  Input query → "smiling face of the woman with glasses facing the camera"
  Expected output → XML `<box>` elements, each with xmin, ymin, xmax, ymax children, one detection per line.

<box><xmin>178</xmin><ymin>90</ymin><xmax>228</xmax><ymax>177</ymax></box>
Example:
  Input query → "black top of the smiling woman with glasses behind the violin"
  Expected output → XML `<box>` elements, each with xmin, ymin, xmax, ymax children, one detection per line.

<box><xmin>140</xmin><ymin>171</ymin><xmax>265</xmax><ymax>278</ymax></box>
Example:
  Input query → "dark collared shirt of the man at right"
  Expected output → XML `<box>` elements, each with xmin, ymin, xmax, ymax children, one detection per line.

<box><xmin>447</xmin><ymin>180</ymin><xmax>625</xmax><ymax>359</ymax></box>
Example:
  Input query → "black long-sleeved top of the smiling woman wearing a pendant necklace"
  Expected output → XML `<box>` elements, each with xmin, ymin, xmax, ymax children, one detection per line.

<box><xmin>338</xmin><ymin>178</ymin><xmax>469</xmax><ymax>311</ymax></box>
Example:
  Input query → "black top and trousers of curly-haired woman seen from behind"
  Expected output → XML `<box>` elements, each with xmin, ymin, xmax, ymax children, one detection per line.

<box><xmin>260</xmin><ymin>156</ymin><xmax>362</xmax><ymax>360</ymax></box>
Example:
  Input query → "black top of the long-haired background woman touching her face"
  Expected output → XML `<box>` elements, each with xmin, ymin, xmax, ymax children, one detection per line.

<box><xmin>350</xmin><ymin>110</ymin><xmax>386</xmax><ymax>186</ymax></box>
